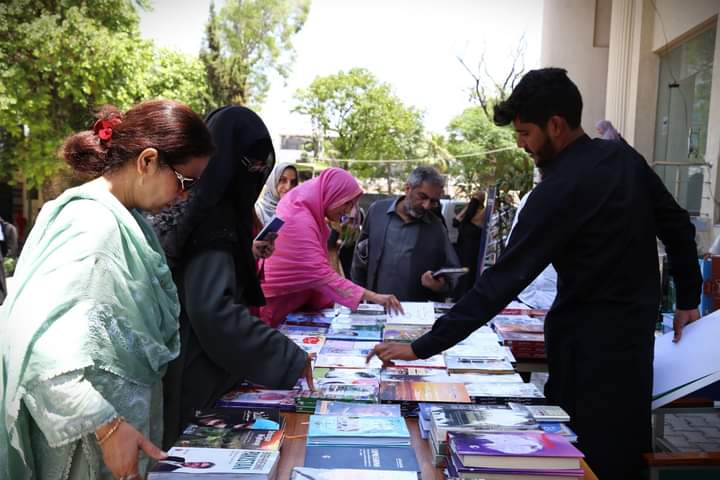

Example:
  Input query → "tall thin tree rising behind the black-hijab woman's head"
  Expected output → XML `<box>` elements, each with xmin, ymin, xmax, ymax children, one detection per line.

<box><xmin>200</xmin><ymin>0</ymin><xmax>310</xmax><ymax>107</ymax></box>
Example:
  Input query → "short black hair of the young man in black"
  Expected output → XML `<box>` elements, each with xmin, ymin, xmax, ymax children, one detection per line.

<box><xmin>493</xmin><ymin>68</ymin><xmax>582</xmax><ymax>129</ymax></box>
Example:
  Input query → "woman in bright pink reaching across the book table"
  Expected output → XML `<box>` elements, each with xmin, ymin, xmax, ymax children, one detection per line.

<box><xmin>260</xmin><ymin>168</ymin><xmax>402</xmax><ymax>327</ymax></box>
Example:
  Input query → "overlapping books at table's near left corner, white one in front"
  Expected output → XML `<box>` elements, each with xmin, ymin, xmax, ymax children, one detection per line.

<box><xmin>148</xmin><ymin>408</ymin><xmax>284</xmax><ymax>480</ymax></box>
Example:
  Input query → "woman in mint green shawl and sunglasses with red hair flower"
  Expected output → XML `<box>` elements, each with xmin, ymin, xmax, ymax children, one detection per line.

<box><xmin>0</xmin><ymin>100</ymin><xmax>213</xmax><ymax>480</ymax></box>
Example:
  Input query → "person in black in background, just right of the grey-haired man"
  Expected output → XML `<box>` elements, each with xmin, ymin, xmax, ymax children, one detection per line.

<box><xmin>453</xmin><ymin>190</ymin><xmax>485</xmax><ymax>298</ymax></box>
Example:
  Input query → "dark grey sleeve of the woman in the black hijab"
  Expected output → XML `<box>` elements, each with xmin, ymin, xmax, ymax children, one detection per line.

<box><xmin>183</xmin><ymin>250</ymin><xmax>307</xmax><ymax>388</ymax></box>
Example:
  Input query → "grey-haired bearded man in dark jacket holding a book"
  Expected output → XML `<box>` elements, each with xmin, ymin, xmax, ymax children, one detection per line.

<box><xmin>352</xmin><ymin>166</ymin><xmax>460</xmax><ymax>302</ymax></box>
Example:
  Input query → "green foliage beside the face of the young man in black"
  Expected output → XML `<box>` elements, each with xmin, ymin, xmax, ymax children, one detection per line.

<box><xmin>447</xmin><ymin>106</ymin><xmax>532</xmax><ymax>196</ymax></box>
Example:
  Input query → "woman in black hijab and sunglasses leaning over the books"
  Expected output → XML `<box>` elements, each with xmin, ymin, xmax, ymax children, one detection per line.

<box><xmin>153</xmin><ymin>106</ymin><xmax>312</xmax><ymax>448</ymax></box>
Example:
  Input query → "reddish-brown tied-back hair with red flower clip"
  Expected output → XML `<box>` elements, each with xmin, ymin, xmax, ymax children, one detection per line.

<box><xmin>61</xmin><ymin>100</ymin><xmax>214</xmax><ymax>175</ymax></box>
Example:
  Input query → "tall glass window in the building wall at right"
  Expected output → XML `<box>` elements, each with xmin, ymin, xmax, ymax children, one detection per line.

<box><xmin>654</xmin><ymin>27</ymin><xmax>716</xmax><ymax>215</ymax></box>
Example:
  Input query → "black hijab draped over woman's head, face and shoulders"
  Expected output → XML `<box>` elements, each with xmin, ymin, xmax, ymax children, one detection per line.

<box><xmin>151</xmin><ymin>106</ymin><xmax>275</xmax><ymax>305</ymax></box>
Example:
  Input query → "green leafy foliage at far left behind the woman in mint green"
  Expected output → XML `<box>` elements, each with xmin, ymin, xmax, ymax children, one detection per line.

<box><xmin>0</xmin><ymin>0</ymin><xmax>207</xmax><ymax>188</ymax></box>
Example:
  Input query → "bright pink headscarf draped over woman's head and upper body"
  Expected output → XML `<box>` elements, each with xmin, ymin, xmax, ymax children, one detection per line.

<box><xmin>262</xmin><ymin>168</ymin><xmax>362</xmax><ymax>297</ymax></box>
